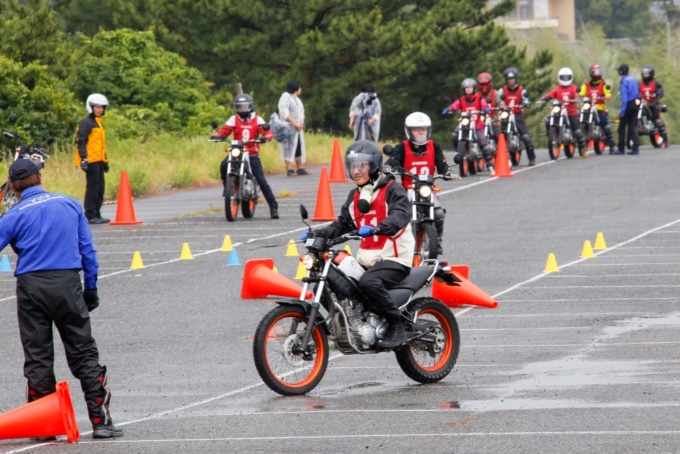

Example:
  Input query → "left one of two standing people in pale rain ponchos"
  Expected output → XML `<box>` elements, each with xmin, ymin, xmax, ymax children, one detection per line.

<box><xmin>277</xmin><ymin>80</ymin><xmax>309</xmax><ymax>177</ymax></box>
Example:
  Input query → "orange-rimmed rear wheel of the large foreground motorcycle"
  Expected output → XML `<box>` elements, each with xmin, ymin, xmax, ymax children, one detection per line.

<box><xmin>395</xmin><ymin>297</ymin><xmax>460</xmax><ymax>383</ymax></box>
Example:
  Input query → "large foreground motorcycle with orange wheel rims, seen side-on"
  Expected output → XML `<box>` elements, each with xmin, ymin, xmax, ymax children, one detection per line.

<box><xmin>253</xmin><ymin>206</ymin><xmax>460</xmax><ymax>396</ymax></box>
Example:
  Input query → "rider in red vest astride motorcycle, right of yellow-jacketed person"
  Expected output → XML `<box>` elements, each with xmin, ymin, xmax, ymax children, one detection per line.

<box><xmin>211</xmin><ymin>94</ymin><xmax>279</xmax><ymax>219</ymax></box>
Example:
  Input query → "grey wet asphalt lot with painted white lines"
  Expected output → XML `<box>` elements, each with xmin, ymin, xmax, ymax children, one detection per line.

<box><xmin>0</xmin><ymin>146</ymin><xmax>680</xmax><ymax>453</ymax></box>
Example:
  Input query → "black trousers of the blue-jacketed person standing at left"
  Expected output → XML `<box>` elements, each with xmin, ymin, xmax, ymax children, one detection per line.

<box><xmin>17</xmin><ymin>270</ymin><xmax>110</xmax><ymax>424</ymax></box>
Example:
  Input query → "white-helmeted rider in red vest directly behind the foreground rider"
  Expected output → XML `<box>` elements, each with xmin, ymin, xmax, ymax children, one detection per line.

<box><xmin>385</xmin><ymin>112</ymin><xmax>460</xmax><ymax>254</ymax></box>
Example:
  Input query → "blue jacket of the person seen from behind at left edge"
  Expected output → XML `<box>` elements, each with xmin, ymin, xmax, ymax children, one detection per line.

<box><xmin>0</xmin><ymin>186</ymin><xmax>99</xmax><ymax>289</ymax></box>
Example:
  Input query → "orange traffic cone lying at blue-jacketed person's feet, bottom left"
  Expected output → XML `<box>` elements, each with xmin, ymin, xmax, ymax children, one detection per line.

<box><xmin>0</xmin><ymin>381</ymin><xmax>80</xmax><ymax>443</ymax></box>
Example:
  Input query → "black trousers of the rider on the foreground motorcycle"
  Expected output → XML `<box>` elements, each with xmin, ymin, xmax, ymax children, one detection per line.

<box><xmin>359</xmin><ymin>260</ymin><xmax>409</xmax><ymax>324</ymax></box>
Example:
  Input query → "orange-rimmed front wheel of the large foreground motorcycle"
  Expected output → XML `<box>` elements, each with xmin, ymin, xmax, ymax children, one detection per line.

<box><xmin>253</xmin><ymin>306</ymin><xmax>329</xmax><ymax>396</ymax></box>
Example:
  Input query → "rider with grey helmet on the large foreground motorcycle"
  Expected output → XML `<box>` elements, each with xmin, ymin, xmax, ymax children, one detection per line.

<box><xmin>310</xmin><ymin>140</ymin><xmax>415</xmax><ymax>348</ymax></box>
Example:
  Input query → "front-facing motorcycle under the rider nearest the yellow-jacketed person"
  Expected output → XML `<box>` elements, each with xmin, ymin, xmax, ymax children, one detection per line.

<box><xmin>210</xmin><ymin>124</ymin><xmax>265</xmax><ymax>222</ymax></box>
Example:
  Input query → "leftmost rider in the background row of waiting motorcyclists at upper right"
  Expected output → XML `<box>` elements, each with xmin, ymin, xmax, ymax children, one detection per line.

<box><xmin>442</xmin><ymin>77</ymin><xmax>495</xmax><ymax>175</ymax></box>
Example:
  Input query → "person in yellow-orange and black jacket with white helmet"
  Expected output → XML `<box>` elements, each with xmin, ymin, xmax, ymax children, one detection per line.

<box><xmin>75</xmin><ymin>93</ymin><xmax>110</xmax><ymax>224</ymax></box>
